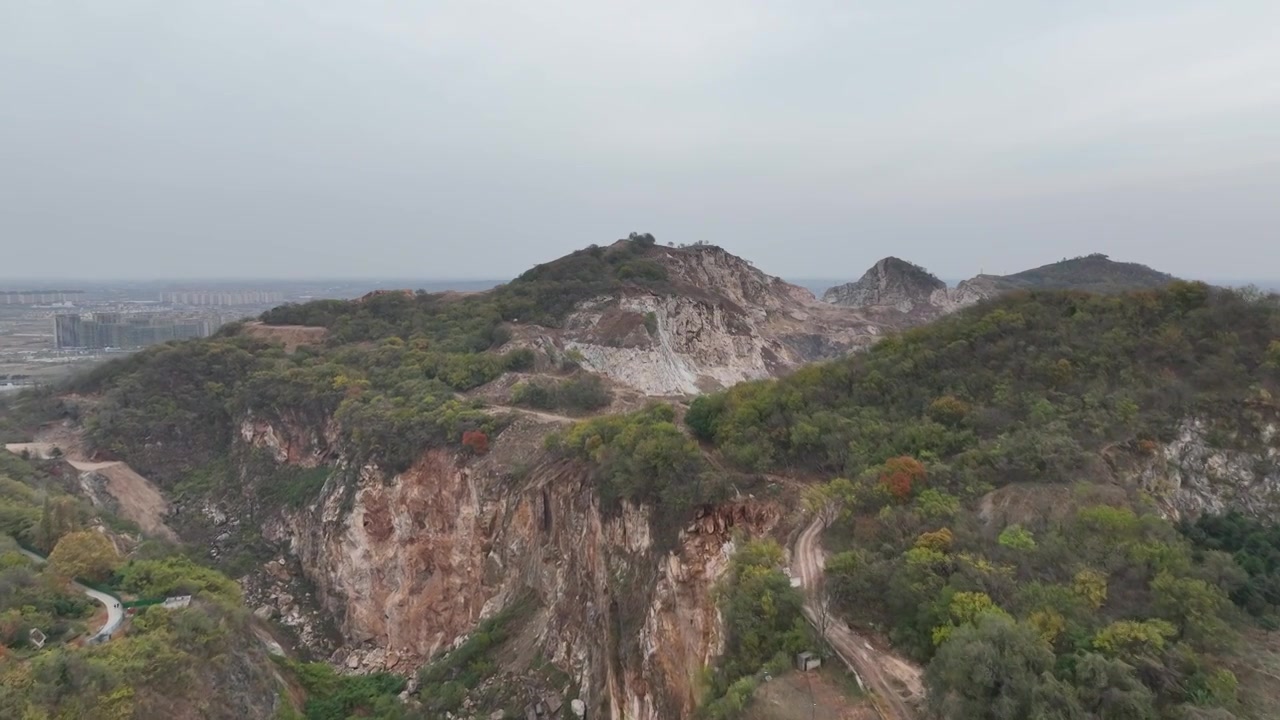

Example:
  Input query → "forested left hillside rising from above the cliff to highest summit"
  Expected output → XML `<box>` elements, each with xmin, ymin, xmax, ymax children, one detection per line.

<box><xmin>73</xmin><ymin>236</ymin><xmax>686</xmax><ymax>482</ymax></box>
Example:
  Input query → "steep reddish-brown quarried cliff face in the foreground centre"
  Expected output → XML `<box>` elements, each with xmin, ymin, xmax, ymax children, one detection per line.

<box><xmin>240</xmin><ymin>412</ymin><xmax>781</xmax><ymax>720</ymax></box>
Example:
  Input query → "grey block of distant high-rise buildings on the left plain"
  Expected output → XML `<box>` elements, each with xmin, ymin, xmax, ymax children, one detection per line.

<box><xmin>54</xmin><ymin>313</ymin><xmax>216</xmax><ymax>350</ymax></box>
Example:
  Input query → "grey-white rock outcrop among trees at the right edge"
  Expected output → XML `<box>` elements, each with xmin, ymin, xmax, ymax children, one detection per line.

<box><xmin>1107</xmin><ymin>418</ymin><xmax>1280</xmax><ymax>520</ymax></box>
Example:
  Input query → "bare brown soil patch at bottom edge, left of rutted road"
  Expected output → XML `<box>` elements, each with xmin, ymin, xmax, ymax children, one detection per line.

<box><xmin>744</xmin><ymin>666</ymin><xmax>878</xmax><ymax>720</ymax></box>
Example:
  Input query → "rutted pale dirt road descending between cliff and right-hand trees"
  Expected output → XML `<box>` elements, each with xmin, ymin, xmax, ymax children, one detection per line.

<box><xmin>791</xmin><ymin>519</ymin><xmax>924</xmax><ymax>720</ymax></box>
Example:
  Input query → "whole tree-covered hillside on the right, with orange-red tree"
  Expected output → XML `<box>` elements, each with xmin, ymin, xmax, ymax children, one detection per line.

<box><xmin>686</xmin><ymin>283</ymin><xmax>1280</xmax><ymax>720</ymax></box>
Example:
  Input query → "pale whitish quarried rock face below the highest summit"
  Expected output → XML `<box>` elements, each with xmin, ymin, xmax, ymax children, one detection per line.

<box><xmin>535</xmin><ymin>246</ymin><xmax>882</xmax><ymax>396</ymax></box>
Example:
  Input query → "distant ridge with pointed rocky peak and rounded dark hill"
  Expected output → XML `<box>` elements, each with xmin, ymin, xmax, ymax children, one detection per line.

<box><xmin>822</xmin><ymin>254</ymin><xmax>1175</xmax><ymax>324</ymax></box>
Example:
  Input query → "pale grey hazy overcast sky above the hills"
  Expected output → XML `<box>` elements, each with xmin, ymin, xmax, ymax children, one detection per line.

<box><xmin>0</xmin><ymin>0</ymin><xmax>1280</xmax><ymax>279</ymax></box>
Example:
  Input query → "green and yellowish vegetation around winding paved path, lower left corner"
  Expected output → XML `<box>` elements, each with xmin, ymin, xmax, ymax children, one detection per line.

<box><xmin>0</xmin><ymin>452</ymin><xmax>303</xmax><ymax>720</ymax></box>
